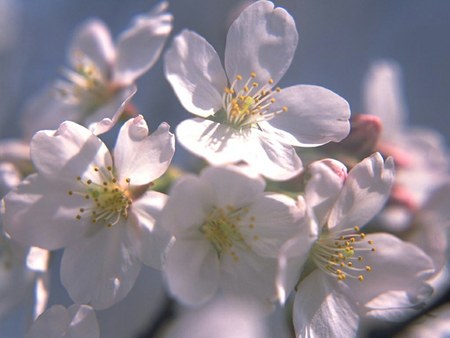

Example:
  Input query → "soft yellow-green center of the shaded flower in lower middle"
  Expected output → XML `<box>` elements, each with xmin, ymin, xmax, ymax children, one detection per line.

<box><xmin>200</xmin><ymin>206</ymin><xmax>254</xmax><ymax>261</ymax></box>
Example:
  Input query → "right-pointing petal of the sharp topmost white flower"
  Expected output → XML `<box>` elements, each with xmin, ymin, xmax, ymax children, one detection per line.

<box><xmin>269</xmin><ymin>85</ymin><xmax>350</xmax><ymax>147</ymax></box>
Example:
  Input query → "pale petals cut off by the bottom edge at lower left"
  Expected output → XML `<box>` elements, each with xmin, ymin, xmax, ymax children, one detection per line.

<box><xmin>26</xmin><ymin>304</ymin><xmax>100</xmax><ymax>338</ymax></box>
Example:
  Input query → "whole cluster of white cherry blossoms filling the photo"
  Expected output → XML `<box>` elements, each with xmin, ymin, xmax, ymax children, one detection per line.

<box><xmin>0</xmin><ymin>0</ymin><xmax>450</xmax><ymax>338</ymax></box>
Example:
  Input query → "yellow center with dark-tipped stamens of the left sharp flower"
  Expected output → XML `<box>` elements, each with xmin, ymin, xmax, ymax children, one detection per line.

<box><xmin>68</xmin><ymin>166</ymin><xmax>132</xmax><ymax>227</ymax></box>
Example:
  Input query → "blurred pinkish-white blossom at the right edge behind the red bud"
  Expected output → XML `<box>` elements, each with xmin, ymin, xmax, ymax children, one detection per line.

<box><xmin>364</xmin><ymin>60</ymin><xmax>449</xmax><ymax>231</ymax></box>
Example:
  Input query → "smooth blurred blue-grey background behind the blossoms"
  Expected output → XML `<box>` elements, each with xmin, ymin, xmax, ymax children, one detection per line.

<box><xmin>0</xmin><ymin>0</ymin><xmax>450</xmax><ymax>337</ymax></box>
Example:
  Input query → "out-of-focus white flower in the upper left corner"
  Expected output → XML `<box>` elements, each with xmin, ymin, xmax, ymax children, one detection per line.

<box><xmin>24</xmin><ymin>2</ymin><xmax>172</xmax><ymax>137</ymax></box>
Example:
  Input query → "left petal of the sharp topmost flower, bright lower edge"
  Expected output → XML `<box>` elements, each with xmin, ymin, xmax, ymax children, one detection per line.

<box><xmin>164</xmin><ymin>30</ymin><xmax>227</xmax><ymax>117</ymax></box>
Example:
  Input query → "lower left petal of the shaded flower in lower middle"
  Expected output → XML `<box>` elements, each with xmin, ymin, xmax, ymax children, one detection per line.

<box><xmin>163</xmin><ymin>235</ymin><xmax>220</xmax><ymax>305</ymax></box>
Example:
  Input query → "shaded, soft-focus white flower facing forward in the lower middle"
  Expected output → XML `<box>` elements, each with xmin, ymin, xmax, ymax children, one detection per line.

<box><xmin>161</xmin><ymin>167</ymin><xmax>304</xmax><ymax>305</ymax></box>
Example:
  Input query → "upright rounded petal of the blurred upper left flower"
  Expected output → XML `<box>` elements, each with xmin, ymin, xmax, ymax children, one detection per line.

<box><xmin>68</xmin><ymin>19</ymin><xmax>115</xmax><ymax>75</ymax></box>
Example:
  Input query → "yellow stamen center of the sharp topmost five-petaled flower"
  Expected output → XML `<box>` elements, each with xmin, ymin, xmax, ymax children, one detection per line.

<box><xmin>222</xmin><ymin>72</ymin><xmax>288</xmax><ymax>129</ymax></box>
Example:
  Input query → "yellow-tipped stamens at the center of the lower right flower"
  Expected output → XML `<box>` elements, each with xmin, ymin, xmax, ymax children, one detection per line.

<box><xmin>311</xmin><ymin>226</ymin><xmax>375</xmax><ymax>282</ymax></box>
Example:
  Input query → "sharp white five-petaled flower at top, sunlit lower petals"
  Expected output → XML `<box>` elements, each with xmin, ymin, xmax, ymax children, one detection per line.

<box><xmin>165</xmin><ymin>1</ymin><xmax>350</xmax><ymax>180</ymax></box>
